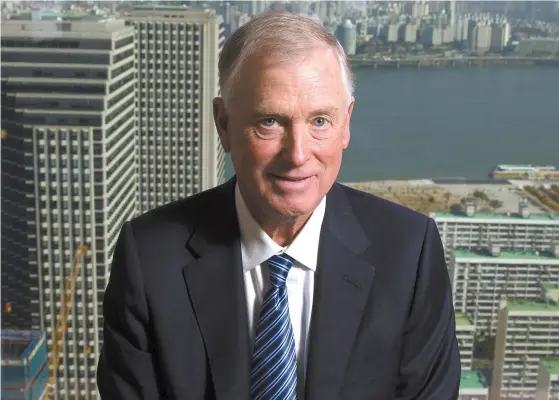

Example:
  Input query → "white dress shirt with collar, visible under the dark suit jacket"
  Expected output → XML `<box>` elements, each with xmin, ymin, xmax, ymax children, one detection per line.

<box><xmin>235</xmin><ymin>185</ymin><xmax>326</xmax><ymax>399</ymax></box>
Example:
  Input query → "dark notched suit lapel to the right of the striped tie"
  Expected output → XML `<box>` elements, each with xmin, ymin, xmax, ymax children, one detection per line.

<box><xmin>305</xmin><ymin>184</ymin><xmax>375</xmax><ymax>400</ymax></box>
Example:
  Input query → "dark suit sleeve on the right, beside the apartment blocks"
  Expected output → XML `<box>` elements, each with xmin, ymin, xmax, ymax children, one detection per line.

<box><xmin>396</xmin><ymin>218</ymin><xmax>460</xmax><ymax>400</ymax></box>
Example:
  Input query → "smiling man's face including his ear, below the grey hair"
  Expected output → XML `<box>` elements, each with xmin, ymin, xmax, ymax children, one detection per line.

<box><xmin>214</xmin><ymin>49</ymin><xmax>353</xmax><ymax>219</ymax></box>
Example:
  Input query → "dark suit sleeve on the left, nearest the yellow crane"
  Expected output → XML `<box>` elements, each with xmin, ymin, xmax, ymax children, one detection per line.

<box><xmin>97</xmin><ymin>222</ymin><xmax>161</xmax><ymax>400</ymax></box>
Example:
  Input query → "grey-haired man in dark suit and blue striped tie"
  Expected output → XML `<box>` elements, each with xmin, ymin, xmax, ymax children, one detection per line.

<box><xmin>98</xmin><ymin>12</ymin><xmax>460</xmax><ymax>400</ymax></box>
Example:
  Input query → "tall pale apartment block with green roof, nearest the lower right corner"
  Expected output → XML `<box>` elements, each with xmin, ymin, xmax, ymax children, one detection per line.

<box><xmin>490</xmin><ymin>290</ymin><xmax>559</xmax><ymax>399</ymax></box>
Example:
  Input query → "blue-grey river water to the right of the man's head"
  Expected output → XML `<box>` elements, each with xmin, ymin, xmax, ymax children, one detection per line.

<box><xmin>226</xmin><ymin>66</ymin><xmax>559</xmax><ymax>181</ymax></box>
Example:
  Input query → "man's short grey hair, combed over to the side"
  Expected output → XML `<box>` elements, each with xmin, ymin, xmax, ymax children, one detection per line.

<box><xmin>218</xmin><ymin>11</ymin><xmax>354</xmax><ymax>105</ymax></box>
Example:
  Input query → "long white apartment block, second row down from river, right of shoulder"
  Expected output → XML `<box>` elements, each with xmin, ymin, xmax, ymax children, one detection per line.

<box><xmin>449</xmin><ymin>245</ymin><xmax>559</xmax><ymax>336</ymax></box>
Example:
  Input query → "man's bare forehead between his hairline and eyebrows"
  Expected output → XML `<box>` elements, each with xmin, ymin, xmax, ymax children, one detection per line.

<box><xmin>234</xmin><ymin>49</ymin><xmax>346</xmax><ymax>108</ymax></box>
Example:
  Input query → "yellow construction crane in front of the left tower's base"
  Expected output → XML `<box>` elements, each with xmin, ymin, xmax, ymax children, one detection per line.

<box><xmin>44</xmin><ymin>246</ymin><xmax>89</xmax><ymax>400</ymax></box>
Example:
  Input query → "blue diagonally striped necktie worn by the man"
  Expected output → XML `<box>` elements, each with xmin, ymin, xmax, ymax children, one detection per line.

<box><xmin>250</xmin><ymin>254</ymin><xmax>297</xmax><ymax>400</ymax></box>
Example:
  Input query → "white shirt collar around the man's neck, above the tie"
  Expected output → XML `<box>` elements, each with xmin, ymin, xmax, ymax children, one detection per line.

<box><xmin>235</xmin><ymin>185</ymin><xmax>326</xmax><ymax>272</ymax></box>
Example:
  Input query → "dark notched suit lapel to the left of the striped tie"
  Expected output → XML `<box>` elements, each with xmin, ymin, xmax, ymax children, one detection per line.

<box><xmin>183</xmin><ymin>180</ymin><xmax>250</xmax><ymax>399</ymax></box>
